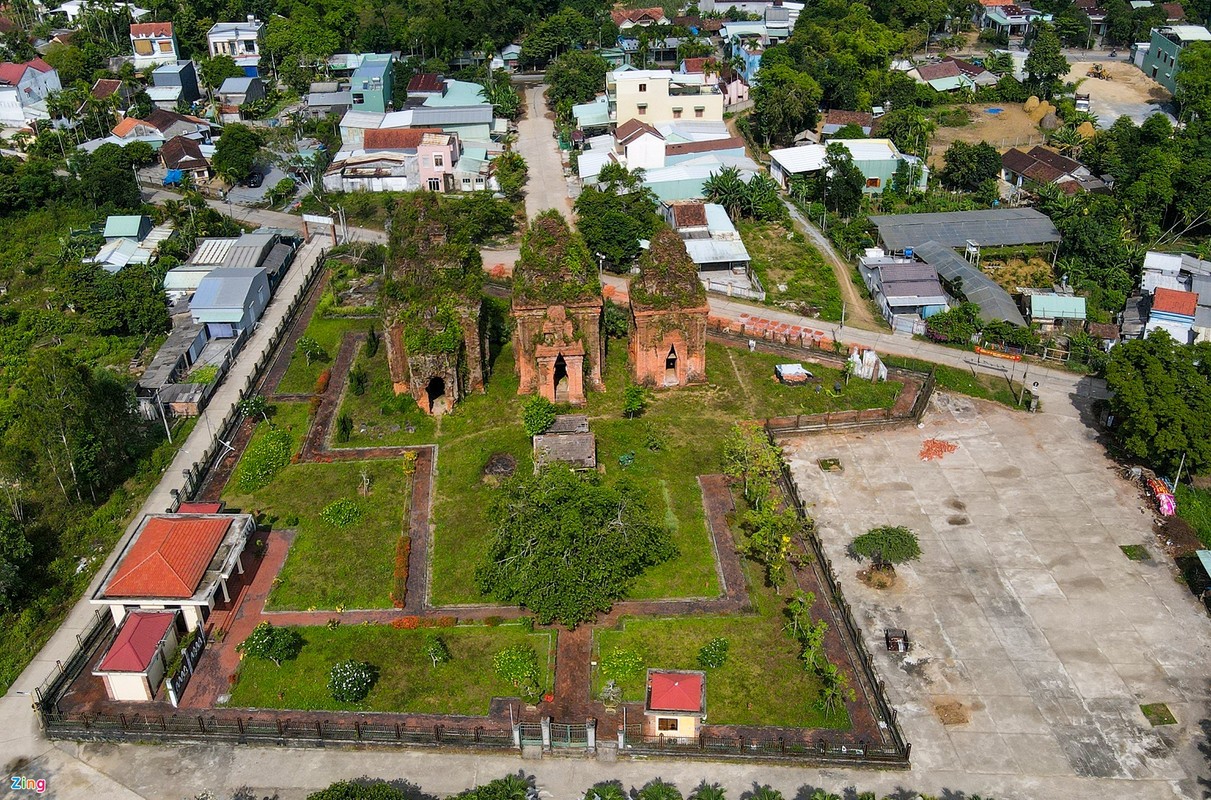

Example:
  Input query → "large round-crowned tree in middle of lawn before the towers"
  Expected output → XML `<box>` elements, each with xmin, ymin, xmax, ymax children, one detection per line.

<box><xmin>476</xmin><ymin>465</ymin><xmax>677</xmax><ymax>627</ymax></box>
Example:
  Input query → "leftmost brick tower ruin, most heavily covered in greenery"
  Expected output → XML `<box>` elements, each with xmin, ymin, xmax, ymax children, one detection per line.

<box><xmin>383</xmin><ymin>192</ymin><xmax>488</xmax><ymax>414</ymax></box>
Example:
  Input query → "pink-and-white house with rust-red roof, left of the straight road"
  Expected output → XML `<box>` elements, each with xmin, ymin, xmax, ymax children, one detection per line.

<box><xmin>323</xmin><ymin>128</ymin><xmax>460</xmax><ymax>192</ymax></box>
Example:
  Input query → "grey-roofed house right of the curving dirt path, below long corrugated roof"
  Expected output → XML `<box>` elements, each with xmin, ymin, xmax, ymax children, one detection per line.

<box><xmin>857</xmin><ymin>247</ymin><xmax>949</xmax><ymax>334</ymax></box>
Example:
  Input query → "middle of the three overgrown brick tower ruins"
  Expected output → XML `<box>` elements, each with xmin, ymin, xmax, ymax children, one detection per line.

<box><xmin>512</xmin><ymin>211</ymin><xmax>606</xmax><ymax>405</ymax></box>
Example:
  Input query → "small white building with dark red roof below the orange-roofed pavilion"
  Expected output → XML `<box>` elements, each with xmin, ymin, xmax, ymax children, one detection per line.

<box><xmin>92</xmin><ymin>611</ymin><xmax>179</xmax><ymax>702</ymax></box>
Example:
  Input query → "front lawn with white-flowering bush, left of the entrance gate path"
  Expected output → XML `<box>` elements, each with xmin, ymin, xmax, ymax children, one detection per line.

<box><xmin>230</xmin><ymin>625</ymin><xmax>556</xmax><ymax>715</ymax></box>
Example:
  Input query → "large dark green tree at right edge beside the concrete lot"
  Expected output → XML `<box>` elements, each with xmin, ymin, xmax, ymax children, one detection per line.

<box><xmin>1106</xmin><ymin>330</ymin><xmax>1211</xmax><ymax>473</ymax></box>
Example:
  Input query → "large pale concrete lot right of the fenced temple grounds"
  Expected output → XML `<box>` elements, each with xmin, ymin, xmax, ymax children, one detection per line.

<box><xmin>784</xmin><ymin>393</ymin><xmax>1211</xmax><ymax>799</ymax></box>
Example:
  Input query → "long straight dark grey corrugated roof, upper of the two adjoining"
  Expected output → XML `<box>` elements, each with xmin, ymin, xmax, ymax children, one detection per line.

<box><xmin>871</xmin><ymin>208</ymin><xmax>1060</xmax><ymax>251</ymax></box>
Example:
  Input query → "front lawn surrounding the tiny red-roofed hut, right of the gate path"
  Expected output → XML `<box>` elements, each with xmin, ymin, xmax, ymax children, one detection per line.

<box><xmin>593</xmin><ymin>564</ymin><xmax>849</xmax><ymax>729</ymax></box>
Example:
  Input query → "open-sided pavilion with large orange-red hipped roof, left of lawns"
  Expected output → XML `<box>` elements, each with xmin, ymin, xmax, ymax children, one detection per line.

<box><xmin>91</xmin><ymin>513</ymin><xmax>257</xmax><ymax>631</ymax></box>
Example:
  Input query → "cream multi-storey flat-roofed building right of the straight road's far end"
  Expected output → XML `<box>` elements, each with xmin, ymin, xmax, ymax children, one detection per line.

<box><xmin>606</xmin><ymin>69</ymin><xmax>723</xmax><ymax>125</ymax></box>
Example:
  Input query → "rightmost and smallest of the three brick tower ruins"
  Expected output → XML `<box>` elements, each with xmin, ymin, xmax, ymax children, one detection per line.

<box><xmin>629</xmin><ymin>228</ymin><xmax>710</xmax><ymax>389</ymax></box>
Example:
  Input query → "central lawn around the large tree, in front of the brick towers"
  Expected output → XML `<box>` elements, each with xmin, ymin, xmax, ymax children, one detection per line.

<box><xmin>431</xmin><ymin>341</ymin><xmax>900</xmax><ymax>605</ymax></box>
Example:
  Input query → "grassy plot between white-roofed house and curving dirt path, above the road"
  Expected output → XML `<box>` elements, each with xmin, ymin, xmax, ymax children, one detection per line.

<box><xmin>736</xmin><ymin>219</ymin><xmax>842</xmax><ymax>322</ymax></box>
